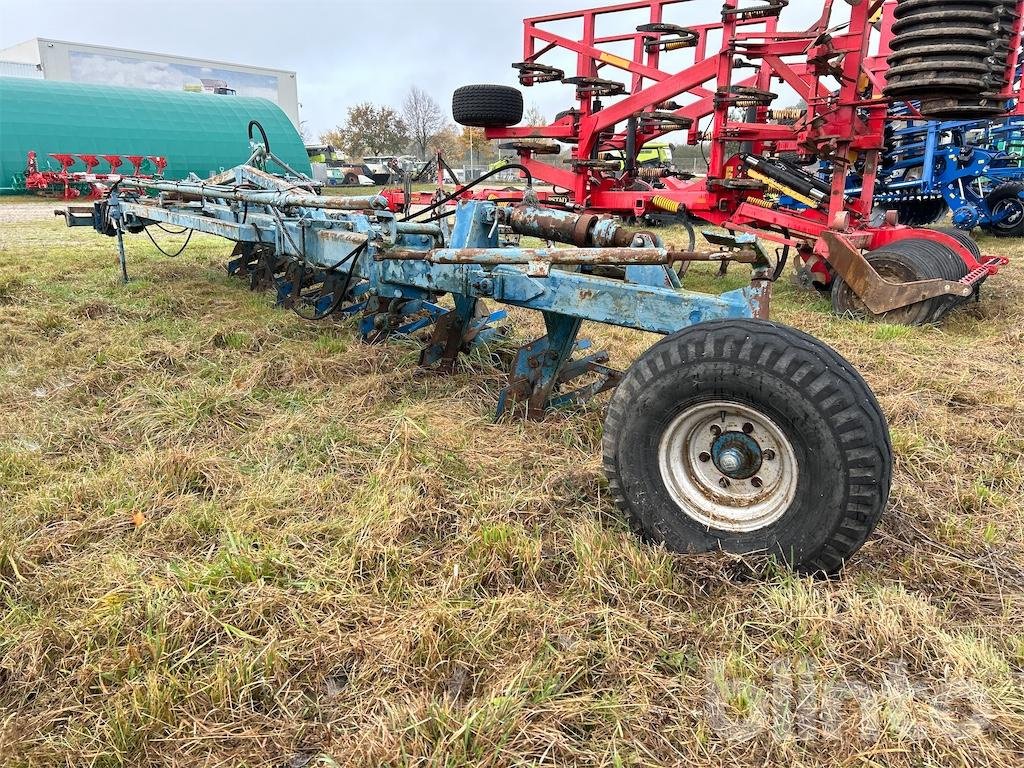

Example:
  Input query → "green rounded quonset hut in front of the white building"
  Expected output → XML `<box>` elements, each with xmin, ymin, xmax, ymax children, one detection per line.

<box><xmin>0</xmin><ymin>77</ymin><xmax>311</xmax><ymax>193</ymax></box>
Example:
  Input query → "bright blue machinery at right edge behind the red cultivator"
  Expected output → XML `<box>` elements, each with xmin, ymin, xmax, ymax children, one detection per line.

<box><xmin>851</xmin><ymin>104</ymin><xmax>1024</xmax><ymax>237</ymax></box>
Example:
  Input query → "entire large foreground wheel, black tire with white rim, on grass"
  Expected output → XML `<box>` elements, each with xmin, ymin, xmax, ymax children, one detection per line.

<box><xmin>603</xmin><ymin>319</ymin><xmax>892</xmax><ymax>573</ymax></box>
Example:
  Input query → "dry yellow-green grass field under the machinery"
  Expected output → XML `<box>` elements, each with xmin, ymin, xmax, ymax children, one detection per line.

<box><xmin>0</xmin><ymin>208</ymin><xmax>1024</xmax><ymax>768</ymax></box>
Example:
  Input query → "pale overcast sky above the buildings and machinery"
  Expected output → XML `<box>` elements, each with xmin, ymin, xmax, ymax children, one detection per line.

<box><xmin>0</xmin><ymin>0</ymin><xmax>820</xmax><ymax>136</ymax></box>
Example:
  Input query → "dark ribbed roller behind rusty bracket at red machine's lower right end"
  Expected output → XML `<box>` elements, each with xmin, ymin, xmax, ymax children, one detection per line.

<box><xmin>831</xmin><ymin>228</ymin><xmax>981</xmax><ymax>326</ymax></box>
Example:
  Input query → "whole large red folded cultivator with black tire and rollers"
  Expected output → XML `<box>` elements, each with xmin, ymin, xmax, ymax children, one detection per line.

<box><xmin>385</xmin><ymin>0</ymin><xmax>1021</xmax><ymax>323</ymax></box>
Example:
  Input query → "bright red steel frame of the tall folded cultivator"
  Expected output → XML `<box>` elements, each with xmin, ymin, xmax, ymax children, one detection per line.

<box><xmin>385</xmin><ymin>0</ymin><xmax>1022</xmax><ymax>296</ymax></box>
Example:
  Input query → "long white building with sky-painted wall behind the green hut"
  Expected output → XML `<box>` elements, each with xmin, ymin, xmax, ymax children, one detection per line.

<box><xmin>0</xmin><ymin>38</ymin><xmax>299</xmax><ymax>128</ymax></box>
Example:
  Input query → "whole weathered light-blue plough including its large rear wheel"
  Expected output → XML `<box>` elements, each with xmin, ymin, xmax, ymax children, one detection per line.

<box><xmin>65</xmin><ymin>135</ymin><xmax>892</xmax><ymax>572</ymax></box>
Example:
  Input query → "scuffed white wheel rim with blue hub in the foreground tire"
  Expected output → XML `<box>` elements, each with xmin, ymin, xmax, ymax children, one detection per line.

<box><xmin>657</xmin><ymin>400</ymin><xmax>799</xmax><ymax>532</ymax></box>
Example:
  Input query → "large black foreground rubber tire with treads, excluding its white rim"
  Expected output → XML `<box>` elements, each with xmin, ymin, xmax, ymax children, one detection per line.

<box><xmin>603</xmin><ymin>319</ymin><xmax>892</xmax><ymax>573</ymax></box>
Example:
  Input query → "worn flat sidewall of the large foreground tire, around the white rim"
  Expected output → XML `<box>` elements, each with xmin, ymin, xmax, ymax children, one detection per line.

<box><xmin>615</xmin><ymin>360</ymin><xmax>849</xmax><ymax>565</ymax></box>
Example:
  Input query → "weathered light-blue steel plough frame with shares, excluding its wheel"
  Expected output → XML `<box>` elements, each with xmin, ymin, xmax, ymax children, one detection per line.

<box><xmin>91</xmin><ymin>166</ymin><xmax>771</xmax><ymax>417</ymax></box>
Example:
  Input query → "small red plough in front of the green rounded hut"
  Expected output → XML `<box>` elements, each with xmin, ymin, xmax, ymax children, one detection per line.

<box><xmin>25</xmin><ymin>152</ymin><xmax>167</xmax><ymax>200</ymax></box>
